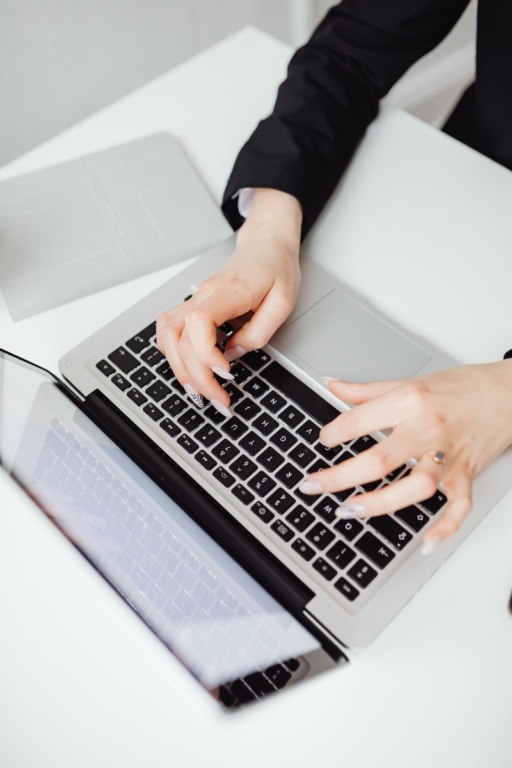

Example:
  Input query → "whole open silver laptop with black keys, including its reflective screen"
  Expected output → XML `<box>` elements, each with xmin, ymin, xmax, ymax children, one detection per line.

<box><xmin>1</xmin><ymin>237</ymin><xmax>512</xmax><ymax>710</ymax></box>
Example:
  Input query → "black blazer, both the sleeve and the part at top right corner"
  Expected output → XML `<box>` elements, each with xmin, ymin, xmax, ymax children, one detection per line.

<box><xmin>222</xmin><ymin>0</ymin><xmax>512</xmax><ymax>236</ymax></box>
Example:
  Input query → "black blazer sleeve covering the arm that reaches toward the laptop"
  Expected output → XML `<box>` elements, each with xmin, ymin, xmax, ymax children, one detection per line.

<box><xmin>222</xmin><ymin>0</ymin><xmax>469</xmax><ymax>237</ymax></box>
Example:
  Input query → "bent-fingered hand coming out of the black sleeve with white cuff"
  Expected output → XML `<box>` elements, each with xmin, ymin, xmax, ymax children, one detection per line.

<box><xmin>157</xmin><ymin>189</ymin><xmax>302</xmax><ymax>411</ymax></box>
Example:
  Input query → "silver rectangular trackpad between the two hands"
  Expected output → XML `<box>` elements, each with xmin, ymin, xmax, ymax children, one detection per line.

<box><xmin>276</xmin><ymin>289</ymin><xmax>432</xmax><ymax>381</ymax></box>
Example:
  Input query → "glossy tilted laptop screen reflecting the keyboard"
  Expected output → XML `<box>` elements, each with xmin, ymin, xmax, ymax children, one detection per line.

<box><xmin>0</xmin><ymin>353</ymin><xmax>333</xmax><ymax>707</ymax></box>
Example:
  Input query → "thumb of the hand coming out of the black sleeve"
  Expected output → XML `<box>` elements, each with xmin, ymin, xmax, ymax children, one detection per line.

<box><xmin>226</xmin><ymin>287</ymin><xmax>294</xmax><ymax>351</ymax></box>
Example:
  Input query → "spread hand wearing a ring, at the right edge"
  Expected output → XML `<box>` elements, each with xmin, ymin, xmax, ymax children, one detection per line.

<box><xmin>298</xmin><ymin>360</ymin><xmax>512</xmax><ymax>554</ymax></box>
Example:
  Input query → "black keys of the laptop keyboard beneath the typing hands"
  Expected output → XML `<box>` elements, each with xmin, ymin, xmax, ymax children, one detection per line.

<box><xmin>96</xmin><ymin>323</ymin><xmax>446</xmax><ymax>603</ymax></box>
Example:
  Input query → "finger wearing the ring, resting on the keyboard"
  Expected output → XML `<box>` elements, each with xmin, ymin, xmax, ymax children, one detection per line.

<box><xmin>336</xmin><ymin>456</ymin><xmax>444</xmax><ymax>520</ymax></box>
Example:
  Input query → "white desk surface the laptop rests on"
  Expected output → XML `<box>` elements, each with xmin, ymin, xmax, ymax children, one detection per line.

<box><xmin>0</xmin><ymin>30</ymin><xmax>512</xmax><ymax>768</ymax></box>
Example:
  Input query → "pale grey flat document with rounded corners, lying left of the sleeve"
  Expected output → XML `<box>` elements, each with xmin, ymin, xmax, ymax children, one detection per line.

<box><xmin>0</xmin><ymin>133</ymin><xmax>231</xmax><ymax>320</ymax></box>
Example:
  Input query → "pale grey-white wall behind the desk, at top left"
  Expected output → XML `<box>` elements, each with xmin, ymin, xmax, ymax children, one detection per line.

<box><xmin>0</xmin><ymin>0</ymin><xmax>293</xmax><ymax>165</ymax></box>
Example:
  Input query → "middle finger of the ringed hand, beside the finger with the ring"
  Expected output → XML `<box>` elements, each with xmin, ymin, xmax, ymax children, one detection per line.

<box><xmin>303</xmin><ymin>430</ymin><xmax>425</xmax><ymax>498</ymax></box>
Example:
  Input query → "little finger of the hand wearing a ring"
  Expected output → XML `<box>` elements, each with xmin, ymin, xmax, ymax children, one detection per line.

<box><xmin>422</xmin><ymin>466</ymin><xmax>473</xmax><ymax>555</ymax></box>
